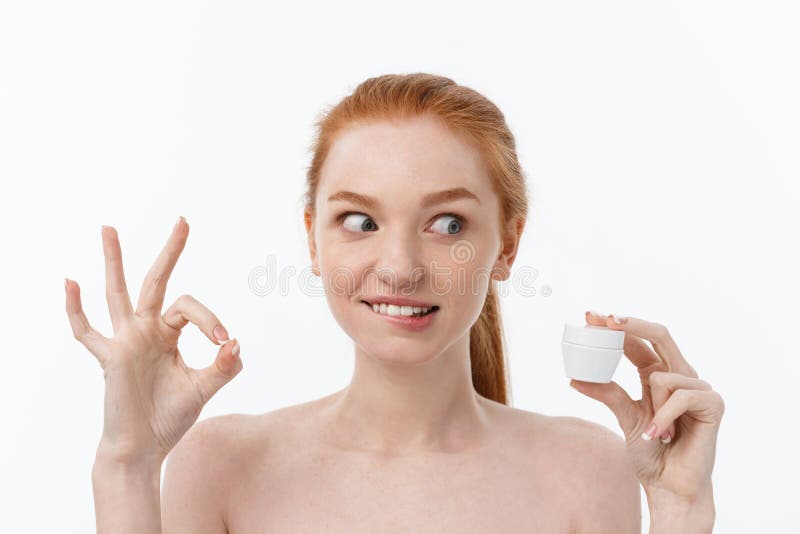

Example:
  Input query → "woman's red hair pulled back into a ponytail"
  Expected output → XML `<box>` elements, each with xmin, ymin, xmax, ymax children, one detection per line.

<box><xmin>305</xmin><ymin>73</ymin><xmax>528</xmax><ymax>404</ymax></box>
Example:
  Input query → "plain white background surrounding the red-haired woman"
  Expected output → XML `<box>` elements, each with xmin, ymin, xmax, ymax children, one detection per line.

<box><xmin>0</xmin><ymin>0</ymin><xmax>800</xmax><ymax>533</ymax></box>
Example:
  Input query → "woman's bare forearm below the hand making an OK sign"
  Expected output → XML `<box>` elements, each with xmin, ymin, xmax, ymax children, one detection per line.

<box><xmin>92</xmin><ymin>453</ymin><xmax>161</xmax><ymax>534</ymax></box>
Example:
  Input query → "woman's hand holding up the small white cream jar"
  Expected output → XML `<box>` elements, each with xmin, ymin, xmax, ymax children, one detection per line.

<box><xmin>570</xmin><ymin>312</ymin><xmax>725</xmax><ymax>502</ymax></box>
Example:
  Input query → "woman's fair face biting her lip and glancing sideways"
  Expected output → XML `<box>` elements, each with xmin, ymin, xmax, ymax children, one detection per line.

<box><xmin>306</xmin><ymin>112</ymin><xmax>518</xmax><ymax>363</ymax></box>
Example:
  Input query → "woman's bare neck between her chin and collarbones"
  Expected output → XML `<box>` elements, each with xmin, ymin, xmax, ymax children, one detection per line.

<box><xmin>324</xmin><ymin>333</ymin><xmax>488</xmax><ymax>455</ymax></box>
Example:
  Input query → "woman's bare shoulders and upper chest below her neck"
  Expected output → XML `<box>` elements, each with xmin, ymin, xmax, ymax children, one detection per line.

<box><xmin>163</xmin><ymin>390</ymin><xmax>641</xmax><ymax>534</ymax></box>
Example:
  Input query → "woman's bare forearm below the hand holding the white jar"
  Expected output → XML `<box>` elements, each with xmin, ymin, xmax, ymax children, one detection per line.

<box><xmin>645</xmin><ymin>483</ymin><xmax>716</xmax><ymax>534</ymax></box>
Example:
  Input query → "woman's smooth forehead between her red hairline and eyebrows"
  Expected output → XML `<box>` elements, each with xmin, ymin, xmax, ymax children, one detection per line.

<box><xmin>317</xmin><ymin>116</ymin><xmax>493</xmax><ymax>202</ymax></box>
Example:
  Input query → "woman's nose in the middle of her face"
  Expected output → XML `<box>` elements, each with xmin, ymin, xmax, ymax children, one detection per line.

<box><xmin>375</xmin><ymin>227</ymin><xmax>425</xmax><ymax>292</ymax></box>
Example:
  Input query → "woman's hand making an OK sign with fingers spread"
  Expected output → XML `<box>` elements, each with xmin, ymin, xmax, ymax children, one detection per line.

<box><xmin>64</xmin><ymin>217</ymin><xmax>242</xmax><ymax>465</ymax></box>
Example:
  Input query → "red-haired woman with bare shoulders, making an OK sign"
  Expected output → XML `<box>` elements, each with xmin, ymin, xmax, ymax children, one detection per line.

<box><xmin>65</xmin><ymin>73</ymin><xmax>724</xmax><ymax>534</ymax></box>
